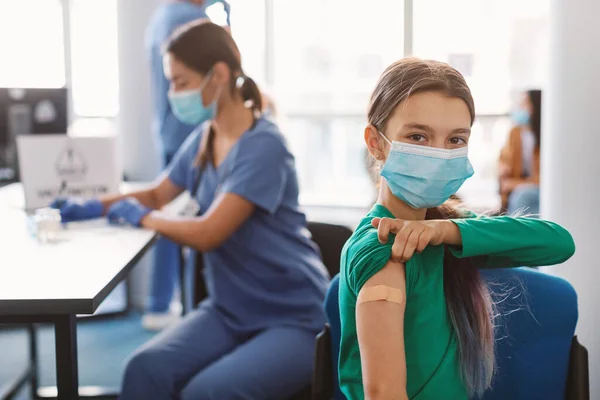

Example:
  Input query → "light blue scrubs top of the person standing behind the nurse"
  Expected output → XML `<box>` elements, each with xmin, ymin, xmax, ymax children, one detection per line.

<box><xmin>146</xmin><ymin>1</ymin><xmax>207</xmax><ymax>158</ymax></box>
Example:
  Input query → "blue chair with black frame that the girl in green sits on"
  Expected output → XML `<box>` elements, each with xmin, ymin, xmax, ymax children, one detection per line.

<box><xmin>313</xmin><ymin>268</ymin><xmax>589</xmax><ymax>400</ymax></box>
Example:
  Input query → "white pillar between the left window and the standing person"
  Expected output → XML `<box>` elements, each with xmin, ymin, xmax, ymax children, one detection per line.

<box><xmin>117</xmin><ymin>0</ymin><xmax>162</xmax><ymax>307</ymax></box>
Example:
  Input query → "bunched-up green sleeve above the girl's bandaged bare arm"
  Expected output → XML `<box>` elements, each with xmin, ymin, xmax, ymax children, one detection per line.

<box><xmin>345</xmin><ymin>228</ymin><xmax>416</xmax><ymax>296</ymax></box>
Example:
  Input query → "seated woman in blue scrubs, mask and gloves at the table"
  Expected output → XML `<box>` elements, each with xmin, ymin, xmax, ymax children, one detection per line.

<box><xmin>52</xmin><ymin>21</ymin><xmax>328</xmax><ymax>400</ymax></box>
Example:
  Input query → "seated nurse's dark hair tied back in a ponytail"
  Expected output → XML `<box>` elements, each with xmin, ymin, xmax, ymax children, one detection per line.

<box><xmin>164</xmin><ymin>19</ymin><xmax>263</xmax><ymax>166</ymax></box>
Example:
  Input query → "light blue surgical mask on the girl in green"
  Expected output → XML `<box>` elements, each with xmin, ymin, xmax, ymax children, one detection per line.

<box><xmin>379</xmin><ymin>132</ymin><xmax>474</xmax><ymax>209</ymax></box>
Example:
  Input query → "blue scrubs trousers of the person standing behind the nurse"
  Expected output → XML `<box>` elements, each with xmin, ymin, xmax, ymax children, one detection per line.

<box><xmin>147</xmin><ymin>154</ymin><xmax>181</xmax><ymax>313</ymax></box>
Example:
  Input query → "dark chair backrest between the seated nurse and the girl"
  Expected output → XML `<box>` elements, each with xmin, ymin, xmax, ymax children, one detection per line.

<box><xmin>308</xmin><ymin>222</ymin><xmax>352</xmax><ymax>276</ymax></box>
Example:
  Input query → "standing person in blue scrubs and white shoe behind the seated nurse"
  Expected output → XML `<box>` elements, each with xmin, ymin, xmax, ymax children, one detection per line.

<box><xmin>142</xmin><ymin>0</ymin><xmax>229</xmax><ymax>330</ymax></box>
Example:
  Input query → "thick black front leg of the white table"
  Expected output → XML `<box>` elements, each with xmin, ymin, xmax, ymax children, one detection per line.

<box><xmin>54</xmin><ymin>315</ymin><xmax>79</xmax><ymax>400</ymax></box>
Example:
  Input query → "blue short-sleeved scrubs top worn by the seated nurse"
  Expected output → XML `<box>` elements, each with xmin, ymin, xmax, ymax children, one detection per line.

<box><xmin>167</xmin><ymin>117</ymin><xmax>329</xmax><ymax>332</ymax></box>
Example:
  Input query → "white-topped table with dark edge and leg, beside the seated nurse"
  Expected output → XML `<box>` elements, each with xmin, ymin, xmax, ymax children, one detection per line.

<box><xmin>0</xmin><ymin>185</ymin><xmax>156</xmax><ymax>400</ymax></box>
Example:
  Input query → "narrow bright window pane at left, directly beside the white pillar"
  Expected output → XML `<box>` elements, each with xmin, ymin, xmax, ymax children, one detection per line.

<box><xmin>71</xmin><ymin>0</ymin><xmax>119</xmax><ymax>117</ymax></box>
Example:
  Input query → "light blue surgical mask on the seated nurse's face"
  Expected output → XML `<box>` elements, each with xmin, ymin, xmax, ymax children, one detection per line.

<box><xmin>168</xmin><ymin>71</ymin><xmax>218</xmax><ymax>125</ymax></box>
